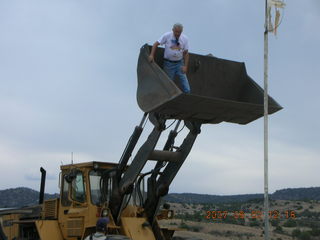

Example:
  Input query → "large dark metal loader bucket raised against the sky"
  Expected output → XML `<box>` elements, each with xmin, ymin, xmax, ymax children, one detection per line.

<box><xmin>137</xmin><ymin>44</ymin><xmax>282</xmax><ymax>124</ymax></box>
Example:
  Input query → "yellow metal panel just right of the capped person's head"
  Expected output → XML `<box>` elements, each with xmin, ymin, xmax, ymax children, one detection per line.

<box><xmin>121</xmin><ymin>217</ymin><xmax>156</xmax><ymax>240</ymax></box>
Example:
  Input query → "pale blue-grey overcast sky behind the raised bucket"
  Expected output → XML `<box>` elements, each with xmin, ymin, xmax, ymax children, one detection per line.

<box><xmin>0</xmin><ymin>0</ymin><xmax>320</xmax><ymax>194</ymax></box>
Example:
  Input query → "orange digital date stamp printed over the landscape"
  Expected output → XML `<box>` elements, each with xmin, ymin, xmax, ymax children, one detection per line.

<box><xmin>205</xmin><ymin>210</ymin><xmax>296</xmax><ymax>220</ymax></box>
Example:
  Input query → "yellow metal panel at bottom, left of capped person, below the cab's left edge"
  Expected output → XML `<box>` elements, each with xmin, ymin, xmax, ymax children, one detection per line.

<box><xmin>36</xmin><ymin>220</ymin><xmax>63</xmax><ymax>240</ymax></box>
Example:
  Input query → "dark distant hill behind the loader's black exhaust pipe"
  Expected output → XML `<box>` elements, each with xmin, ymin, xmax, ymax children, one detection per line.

<box><xmin>0</xmin><ymin>187</ymin><xmax>59</xmax><ymax>208</ymax></box>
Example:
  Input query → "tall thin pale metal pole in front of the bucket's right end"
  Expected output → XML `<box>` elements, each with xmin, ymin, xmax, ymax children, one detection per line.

<box><xmin>264</xmin><ymin>0</ymin><xmax>270</xmax><ymax>240</ymax></box>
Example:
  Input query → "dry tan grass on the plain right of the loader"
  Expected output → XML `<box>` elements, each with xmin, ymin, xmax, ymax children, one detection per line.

<box><xmin>161</xmin><ymin>200</ymin><xmax>320</xmax><ymax>240</ymax></box>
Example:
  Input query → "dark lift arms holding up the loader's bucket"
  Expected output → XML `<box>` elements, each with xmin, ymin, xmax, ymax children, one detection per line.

<box><xmin>109</xmin><ymin>113</ymin><xmax>201</xmax><ymax>239</ymax></box>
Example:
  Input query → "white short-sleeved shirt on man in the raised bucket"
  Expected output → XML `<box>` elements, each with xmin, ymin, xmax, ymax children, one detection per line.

<box><xmin>158</xmin><ymin>31</ymin><xmax>189</xmax><ymax>61</ymax></box>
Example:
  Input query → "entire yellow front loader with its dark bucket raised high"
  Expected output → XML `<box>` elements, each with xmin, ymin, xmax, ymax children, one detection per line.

<box><xmin>0</xmin><ymin>45</ymin><xmax>281</xmax><ymax>240</ymax></box>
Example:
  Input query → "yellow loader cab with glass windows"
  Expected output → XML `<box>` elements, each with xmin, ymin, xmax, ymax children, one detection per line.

<box><xmin>58</xmin><ymin>162</ymin><xmax>117</xmax><ymax>240</ymax></box>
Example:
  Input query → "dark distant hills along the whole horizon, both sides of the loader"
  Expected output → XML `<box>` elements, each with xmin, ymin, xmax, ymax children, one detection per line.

<box><xmin>0</xmin><ymin>187</ymin><xmax>320</xmax><ymax>208</ymax></box>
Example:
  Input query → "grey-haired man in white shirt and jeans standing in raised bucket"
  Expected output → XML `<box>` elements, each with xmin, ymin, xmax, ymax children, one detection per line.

<box><xmin>149</xmin><ymin>23</ymin><xmax>190</xmax><ymax>93</ymax></box>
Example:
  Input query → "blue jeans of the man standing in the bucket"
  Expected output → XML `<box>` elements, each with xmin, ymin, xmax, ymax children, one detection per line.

<box><xmin>163</xmin><ymin>60</ymin><xmax>190</xmax><ymax>93</ymax></box>
